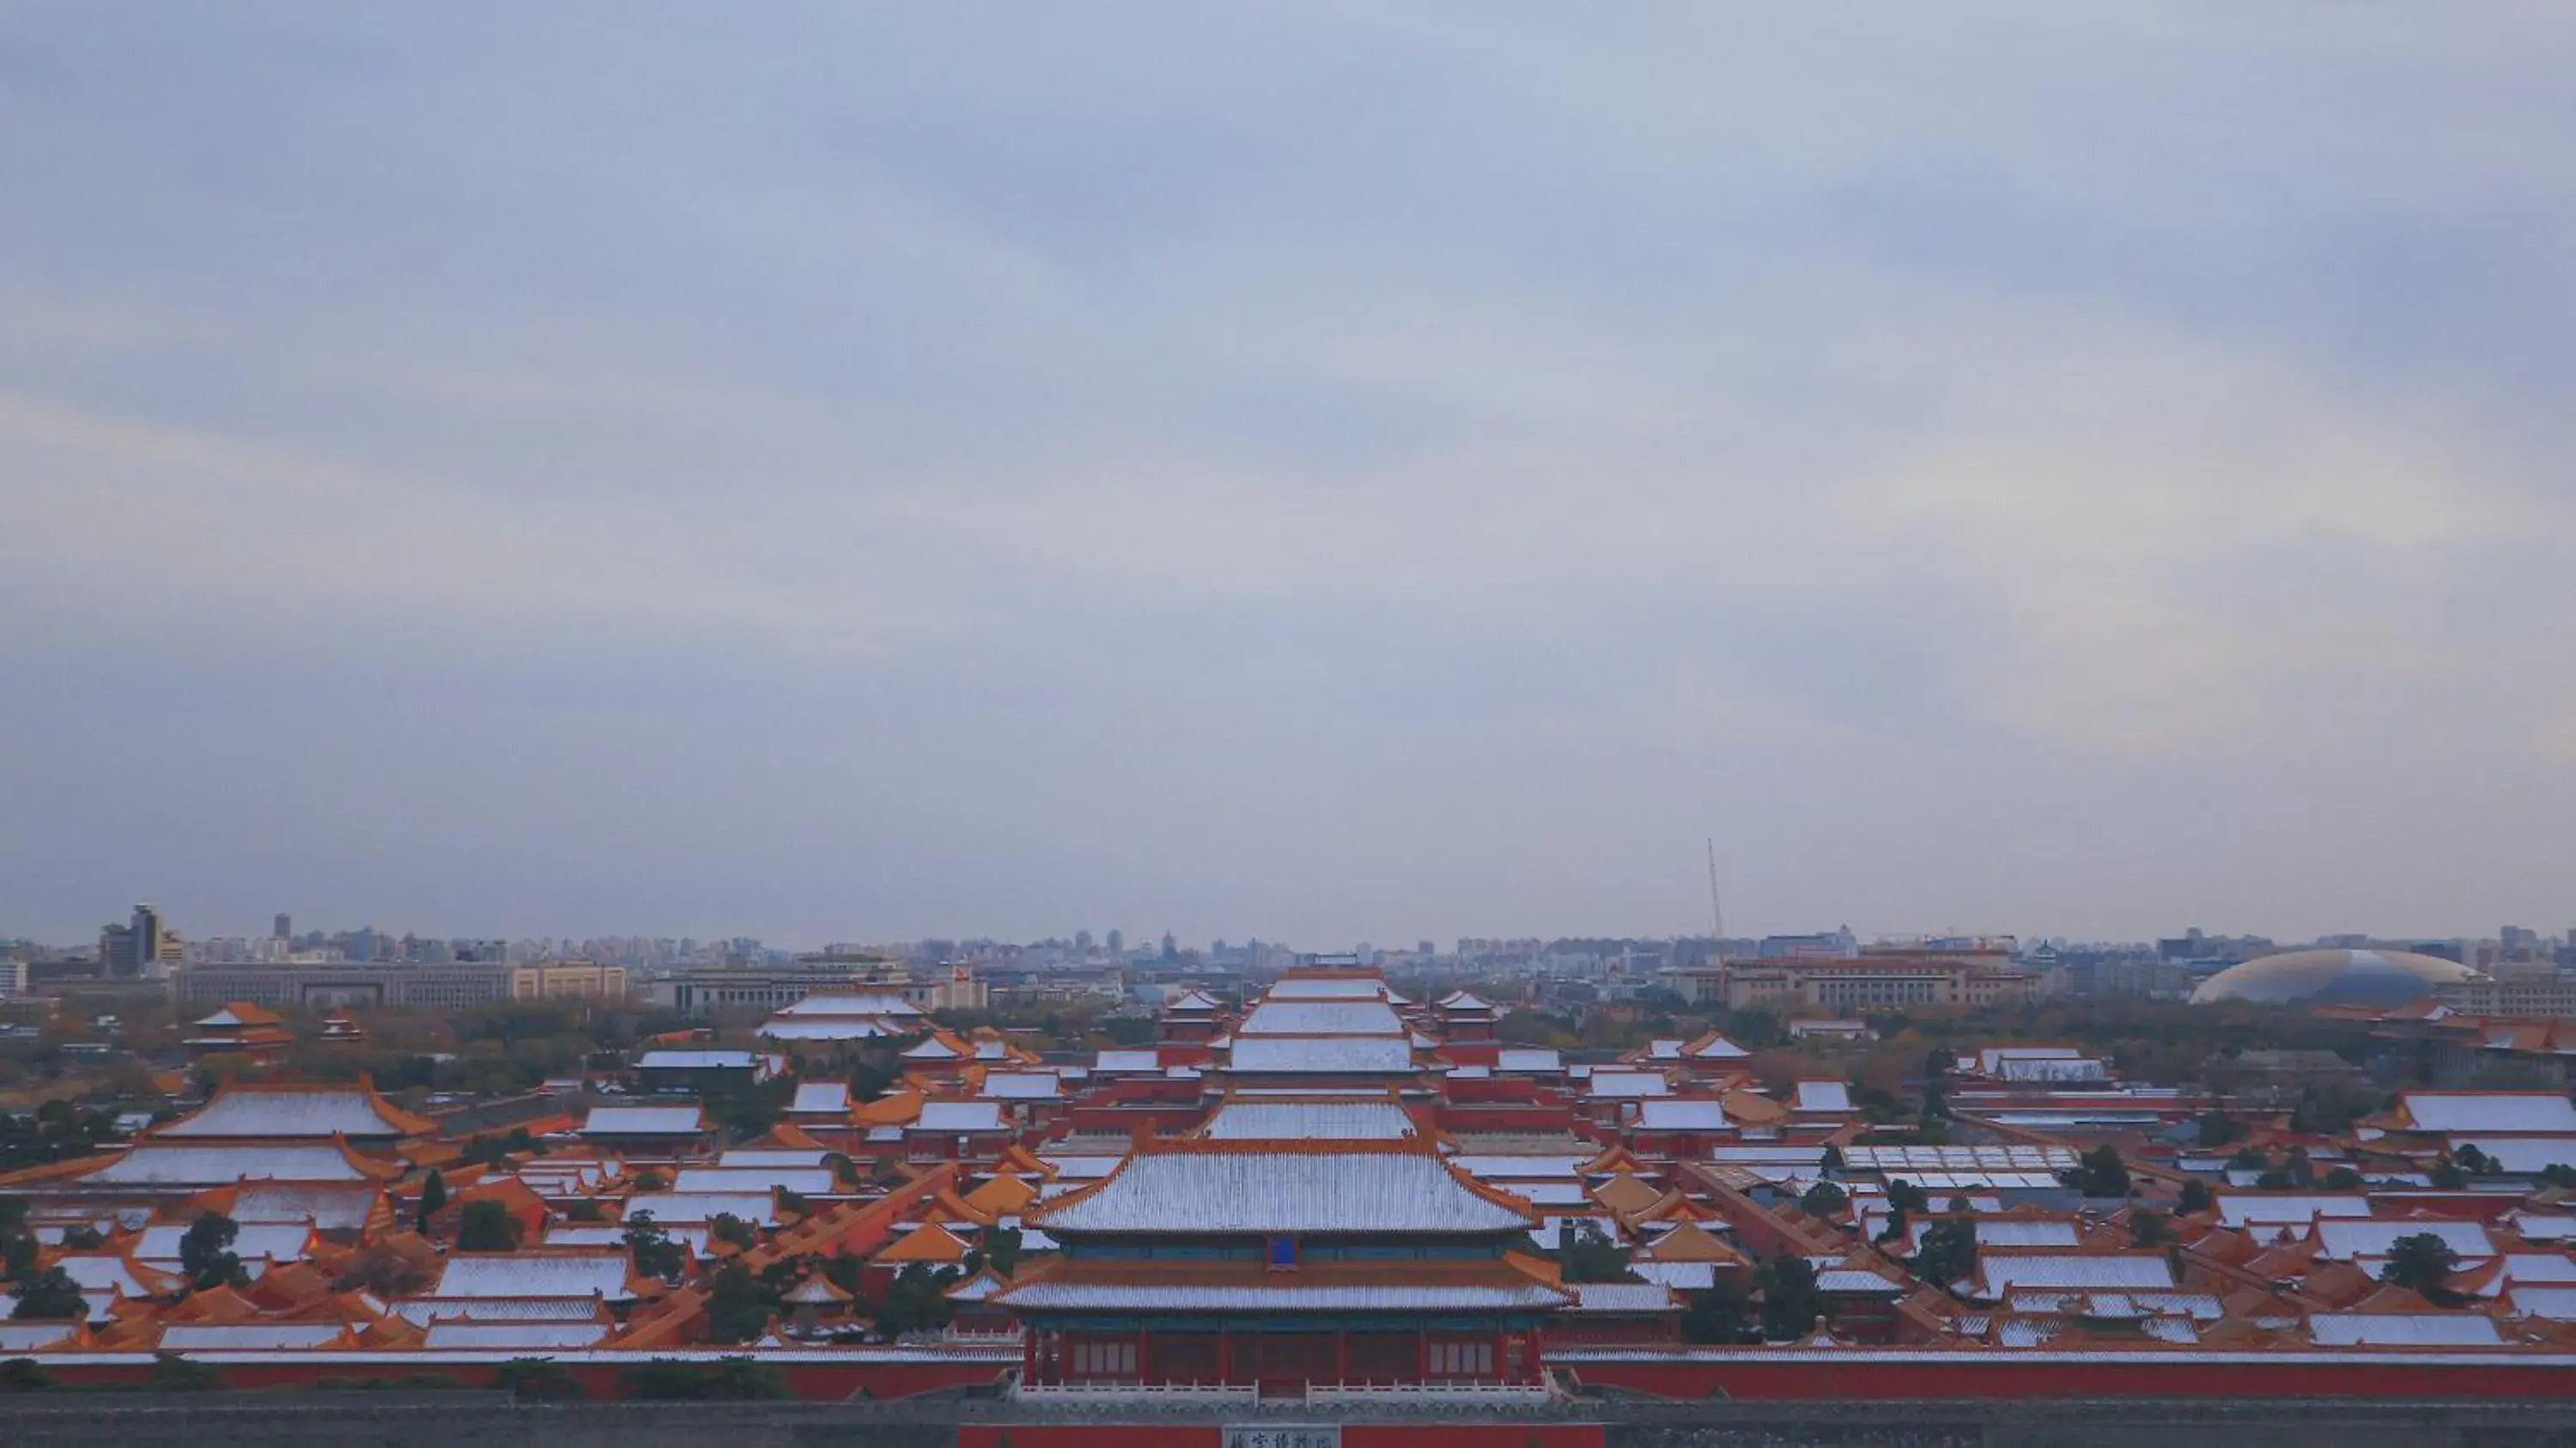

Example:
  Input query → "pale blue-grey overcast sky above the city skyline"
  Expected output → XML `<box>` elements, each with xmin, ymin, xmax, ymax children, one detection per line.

<box><xmin>0</xmin><ymin>0</ymin><xmax>2576</xmax><ymax>948</ymax></box>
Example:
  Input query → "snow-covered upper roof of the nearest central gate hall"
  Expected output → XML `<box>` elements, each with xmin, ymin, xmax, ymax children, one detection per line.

<box><xmin>1030</xmin><ymin>1141</ymin><xmax>1530</xmax><ymax>1237</ymax></box>
